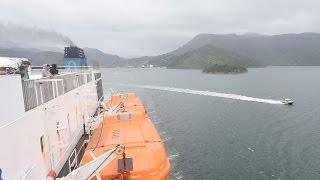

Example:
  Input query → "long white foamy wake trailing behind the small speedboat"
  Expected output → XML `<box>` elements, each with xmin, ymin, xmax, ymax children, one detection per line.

<box><xmin>110</xmin><ymin>83</ymin><xmax>283</xmax><ymax>104</ymax></box>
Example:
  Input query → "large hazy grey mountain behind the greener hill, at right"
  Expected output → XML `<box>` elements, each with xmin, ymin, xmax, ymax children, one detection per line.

<box><xmin>169</xmin><ymin>33</ymin><xmax>320</xmax><ymax>66</ymax></box>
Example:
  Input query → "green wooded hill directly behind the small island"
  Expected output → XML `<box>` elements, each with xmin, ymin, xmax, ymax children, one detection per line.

<box><xmin>148</xmin><ymin>45</ymin><xmax>260</xmax><ymax>69</ymax></box>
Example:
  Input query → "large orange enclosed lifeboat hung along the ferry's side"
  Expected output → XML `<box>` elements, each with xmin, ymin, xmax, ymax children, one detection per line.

<box><xmin>81</xmin><ymin>93</ymin><xmax>170</xmax><ymax>180</ymax></box>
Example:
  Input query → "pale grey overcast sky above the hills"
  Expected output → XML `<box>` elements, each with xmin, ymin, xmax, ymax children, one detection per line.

<box><xmin>0</xmin><ymin>0</ymin><xmax>320</xmax><ymax>57</ymax></box>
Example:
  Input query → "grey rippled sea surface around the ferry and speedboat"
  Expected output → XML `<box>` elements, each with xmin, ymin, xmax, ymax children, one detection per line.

<box><xmin>101</xmin><ymin>67</ymin><xmax>320</xmax><ymax>180</ymax></box>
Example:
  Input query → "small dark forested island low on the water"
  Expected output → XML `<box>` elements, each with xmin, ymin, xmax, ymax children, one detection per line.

<box><xmin>202</xmin><ymin>64</ymin><xmax>248</xmax><ymax>74</ymax></box>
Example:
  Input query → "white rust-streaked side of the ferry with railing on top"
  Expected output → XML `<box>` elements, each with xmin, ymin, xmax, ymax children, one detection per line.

<box><xmin>0</xmin><ymin>70</ymin><xmax>103</xmax><ymax>180</ymax></box>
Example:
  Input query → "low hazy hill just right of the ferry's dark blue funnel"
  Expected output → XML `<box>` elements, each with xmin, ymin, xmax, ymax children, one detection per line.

<box><xmin>83</xmin><ymin>48</ymin><xmax>127</xmax><ymax>67</ymax></box>
